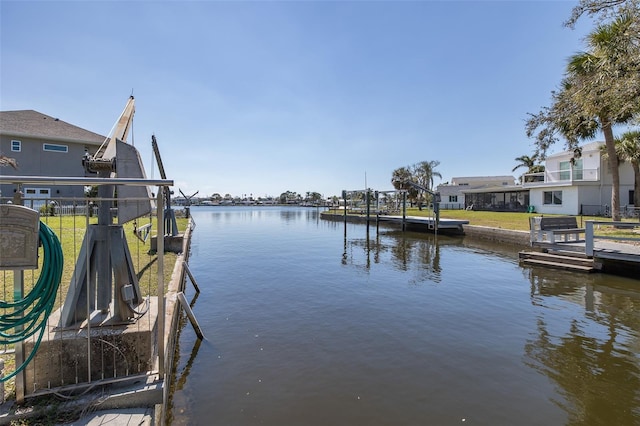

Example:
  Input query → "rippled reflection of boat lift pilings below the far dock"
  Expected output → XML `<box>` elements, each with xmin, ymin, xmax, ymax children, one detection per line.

<box><xmin>342</xmin><ymin>227</ymin><xmax>442</xmax><ymax>282</ymax></box>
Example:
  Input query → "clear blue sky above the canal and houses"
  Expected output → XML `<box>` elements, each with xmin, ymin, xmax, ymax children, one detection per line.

<box><xmin>0</xmin><ymin>0</ymin><xmax>592</xmax><ymax>197</ymax></box>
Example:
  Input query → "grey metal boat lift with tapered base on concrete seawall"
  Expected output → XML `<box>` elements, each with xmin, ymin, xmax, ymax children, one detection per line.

<box><xmin>60</xmin><ymin>96</ymin><xmax>155</xmax><ymax>327</ymax></box>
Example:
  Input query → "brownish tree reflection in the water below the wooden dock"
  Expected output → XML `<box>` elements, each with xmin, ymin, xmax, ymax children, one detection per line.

<box><xmin>524</xmin><ymin>269</ymin><xmax>640</xmax><ymax>425</ymax></box>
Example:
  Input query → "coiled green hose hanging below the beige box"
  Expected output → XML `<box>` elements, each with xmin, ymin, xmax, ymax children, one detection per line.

<box><xmin>0</xmin><ymin>222</ymin><xmax>64</xmax><ymax>382</ymax></box>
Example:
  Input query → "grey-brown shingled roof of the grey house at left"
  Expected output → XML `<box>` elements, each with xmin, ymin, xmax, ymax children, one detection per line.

<box><xmin>0</xmin><ymin>110</ymin><xmax>106</xmax><ymax>145</ymax></box>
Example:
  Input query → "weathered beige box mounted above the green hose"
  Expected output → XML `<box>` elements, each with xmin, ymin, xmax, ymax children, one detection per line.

<box><xmin>0</xmin><ymin>204</ymin><xmax>40</xmax><ymax>270</ymax></box>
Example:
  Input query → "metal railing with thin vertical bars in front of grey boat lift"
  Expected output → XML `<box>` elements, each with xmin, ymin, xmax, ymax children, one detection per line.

<box><xmin>0</xmin><ymin>176</ymin><xmax>173</xmax><ymax>402</ymax></box>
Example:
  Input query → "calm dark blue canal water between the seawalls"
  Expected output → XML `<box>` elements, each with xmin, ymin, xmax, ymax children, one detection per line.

<box><xmin>169</xmin><ymin>207</ymin><xmax>640</xmax><ymax>426</ymax></box>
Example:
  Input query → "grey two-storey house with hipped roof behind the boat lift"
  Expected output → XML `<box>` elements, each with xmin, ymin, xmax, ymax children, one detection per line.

<box><xmin>0</xmin><ymin>110</ymin><xmax>106</xmax><ymax>204</ymax></box>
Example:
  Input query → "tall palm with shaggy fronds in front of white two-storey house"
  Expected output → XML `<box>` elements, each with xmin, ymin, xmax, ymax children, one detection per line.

<box><xmin>527</xmin><ymin>14</ymin><xmax>640</xmax><ymax>221</ymax></box>
